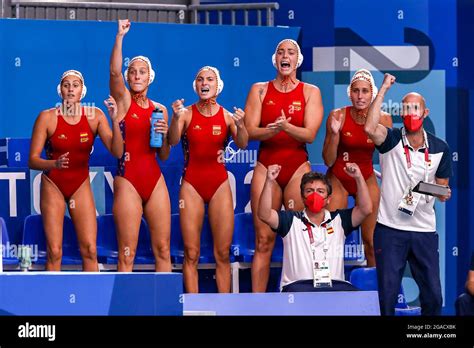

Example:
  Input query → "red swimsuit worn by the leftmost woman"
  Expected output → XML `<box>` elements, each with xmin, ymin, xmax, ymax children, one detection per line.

<box><xmin>44</xmin><ymin>109</ymin><xmax>95</xmax><ymax>201</ymax></box>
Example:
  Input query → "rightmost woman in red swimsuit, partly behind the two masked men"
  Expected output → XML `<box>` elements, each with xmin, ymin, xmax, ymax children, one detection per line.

<box><xmin>323</xmin><ymin>69</ymin><xmax>392</xmax><ymax>267</ymax></box>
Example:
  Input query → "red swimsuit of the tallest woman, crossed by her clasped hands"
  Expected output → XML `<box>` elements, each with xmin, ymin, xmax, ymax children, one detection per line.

<box><xmin>258</xmin><ymin>81</ymin><xmax>308</xmax><ymax>190</ymax></box>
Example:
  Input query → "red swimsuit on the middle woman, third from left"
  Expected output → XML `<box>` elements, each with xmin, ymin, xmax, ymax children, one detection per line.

<box><xmin>182</xmin><ymin>105</ymin><xmax>228</xmax><ymax>203</ymax></box>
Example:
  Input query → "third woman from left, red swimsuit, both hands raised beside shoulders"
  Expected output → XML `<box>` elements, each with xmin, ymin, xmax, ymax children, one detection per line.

<box><xmin>169</xmin><ymin>66</ymin><xmax>248</xmax><ymax>293</ymax></box>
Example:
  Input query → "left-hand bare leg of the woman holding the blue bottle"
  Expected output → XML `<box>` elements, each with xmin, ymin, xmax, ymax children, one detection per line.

<box><xmin>113</xmin><ymin>176</ymin><xmax>143</xmax><ymax>272</ymax></box>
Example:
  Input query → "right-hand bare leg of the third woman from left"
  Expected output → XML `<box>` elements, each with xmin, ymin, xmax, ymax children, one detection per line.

<box><xmin>209</xmin><ymin>180</ymin><xmax>234</xmax><ymax>292</ymax></box>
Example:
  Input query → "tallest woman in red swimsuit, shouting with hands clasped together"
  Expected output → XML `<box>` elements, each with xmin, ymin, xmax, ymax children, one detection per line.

<box><xmin>245</xmin><ymin>39</ymin><xmax>323</xmax><ymax>292</ymax></box>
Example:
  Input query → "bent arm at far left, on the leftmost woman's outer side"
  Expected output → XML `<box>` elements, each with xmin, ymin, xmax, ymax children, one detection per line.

<box><xmin>28</xmin><ymin>110</ymin><xmax>69</xmax><ymax>170</ymax></box>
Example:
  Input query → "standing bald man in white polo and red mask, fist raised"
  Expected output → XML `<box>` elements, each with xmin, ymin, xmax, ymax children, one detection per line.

<box><xmin>365</xmin><ymin>74</ymin><xmax>452</xmax><ymax>315</ymax></box>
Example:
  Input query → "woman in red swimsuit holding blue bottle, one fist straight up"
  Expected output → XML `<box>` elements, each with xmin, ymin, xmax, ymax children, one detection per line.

<box><xmin>108</xmin><ymin>19</ymin><xmax>171</xmax><ymax>272</ymax></box>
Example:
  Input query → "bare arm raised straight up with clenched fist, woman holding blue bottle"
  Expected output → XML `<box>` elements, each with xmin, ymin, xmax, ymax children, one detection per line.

<box><xmin>109</xmin><ymin>19</ymin><xmax>131</xmax><ymax>105</ymax></box>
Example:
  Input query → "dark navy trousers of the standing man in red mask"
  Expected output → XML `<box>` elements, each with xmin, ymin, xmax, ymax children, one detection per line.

<box><xmin>374</xmin><ymin>223</ymin><xmax>443</xmax><ymax>315</ymax></box>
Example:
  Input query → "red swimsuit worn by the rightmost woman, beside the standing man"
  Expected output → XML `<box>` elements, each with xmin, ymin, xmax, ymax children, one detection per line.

<box><xmin>329</xmin><ymin>106</ymin><xmax>375</xmax><ymax>195</ymax></box>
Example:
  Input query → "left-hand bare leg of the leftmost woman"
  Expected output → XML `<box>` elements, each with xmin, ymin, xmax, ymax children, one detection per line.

<box><xmin>40</xmin><ymin>175</ymin><xmax>66</xmax><ymax>271</ymax></box>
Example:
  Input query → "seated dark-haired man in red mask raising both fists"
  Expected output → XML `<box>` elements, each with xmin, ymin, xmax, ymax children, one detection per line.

<box><xmin>259</xmin><ymin>163</ymin><xmax>372</xmax><ymax>292</ymax></box>
